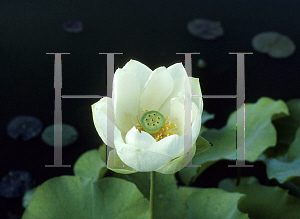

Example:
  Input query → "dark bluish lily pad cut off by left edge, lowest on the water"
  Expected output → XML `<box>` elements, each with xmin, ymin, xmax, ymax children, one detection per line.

<box><xmin>0</xmin><ymin>170</ymin><xmax>35</xmax><ymax>198</ymax></box>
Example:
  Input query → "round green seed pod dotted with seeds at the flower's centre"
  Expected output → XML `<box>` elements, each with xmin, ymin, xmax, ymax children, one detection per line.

<box><xmin>141</xmin><ymin>110</ymin><xmax>165</xmax><ymax>134</ymax></box>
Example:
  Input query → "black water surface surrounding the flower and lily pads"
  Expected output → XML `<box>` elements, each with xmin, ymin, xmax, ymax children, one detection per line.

<box><xmin>0</xmin><ymin>0</ymin><xmax>300</xmax><ymax>218</ymax></box>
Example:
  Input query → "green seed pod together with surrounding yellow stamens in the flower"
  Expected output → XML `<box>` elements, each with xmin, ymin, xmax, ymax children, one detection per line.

<box><xmin>136</xmin><ymin>110</ymin><xmax>176</xmax><ymax>141</ymax></box>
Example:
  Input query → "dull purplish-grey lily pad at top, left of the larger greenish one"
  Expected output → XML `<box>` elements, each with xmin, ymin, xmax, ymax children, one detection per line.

<box><xmin>187</xmin><ymin>19</ymin><xmax>224</xmax><ymax>40</ymax></box>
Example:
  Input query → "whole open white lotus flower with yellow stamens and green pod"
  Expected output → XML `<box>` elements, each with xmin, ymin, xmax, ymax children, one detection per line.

<box><xmin>92</xmin><ymin>60</ymin><xmax>203</xmax><ymax>174</ymax></box>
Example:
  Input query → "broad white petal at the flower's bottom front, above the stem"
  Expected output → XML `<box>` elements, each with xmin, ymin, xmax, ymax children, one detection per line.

<box><xmin>115</xmin><ymin>139</ymin><xmax>171</xmax><ymax>172</ymax></box>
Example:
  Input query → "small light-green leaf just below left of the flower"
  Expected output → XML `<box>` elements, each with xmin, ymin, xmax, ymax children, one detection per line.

<box><xmin>74</xmin><ymin>146</ymin><xmax>107</xmax><ymax>181</ymax></box>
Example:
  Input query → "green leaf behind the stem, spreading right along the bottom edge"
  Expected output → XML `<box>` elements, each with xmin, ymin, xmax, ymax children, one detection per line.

<box><xmin>115</xmin><ymin>172</ymin><xmax>248</xmax><ymax>219</ymax></box>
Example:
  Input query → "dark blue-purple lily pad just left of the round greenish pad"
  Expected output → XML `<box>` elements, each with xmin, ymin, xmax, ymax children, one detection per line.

<box><xmin>7</xmin><ymin>115</ymin><xmax>43</xmax><ymax>141</ymax></box>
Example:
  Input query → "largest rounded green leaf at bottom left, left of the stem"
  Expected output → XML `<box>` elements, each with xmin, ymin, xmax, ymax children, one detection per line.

<box><xmin>22</xmin><ymin>176</ymin><xmax>150</xmax><ymax>219</ymax></box>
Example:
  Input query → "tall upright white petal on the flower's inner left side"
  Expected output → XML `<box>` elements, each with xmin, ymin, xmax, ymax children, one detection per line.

<box><xmin>113</xmin><ymin>69</ymin><xmax>140</xmax><ymax>133</ymax></box>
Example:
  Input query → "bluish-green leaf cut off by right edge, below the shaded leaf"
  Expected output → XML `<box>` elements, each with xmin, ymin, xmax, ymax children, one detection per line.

<box><xmin>259</xmin><ymin>127</ymin><xmax>300</xmax><ymax>183</ymax></box>
